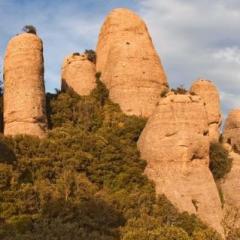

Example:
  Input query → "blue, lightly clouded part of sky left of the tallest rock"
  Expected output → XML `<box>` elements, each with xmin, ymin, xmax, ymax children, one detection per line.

<box><xmin>0</xmin><ymin>0</ymin><xmax>139</xmax><ymax>91</ymax></box>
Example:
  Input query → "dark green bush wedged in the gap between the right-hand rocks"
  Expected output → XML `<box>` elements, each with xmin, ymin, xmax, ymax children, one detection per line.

<box><xmin>210</xmin><ymin>143</ymin><xmax>232</xmax><ymax>179</ymax></box>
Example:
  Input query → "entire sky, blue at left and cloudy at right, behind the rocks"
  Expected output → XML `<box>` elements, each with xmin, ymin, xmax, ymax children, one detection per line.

<box><xmin>0</xmin><ymin>0</ymin><xmax>240</xmax><ymax>119</ymax></box>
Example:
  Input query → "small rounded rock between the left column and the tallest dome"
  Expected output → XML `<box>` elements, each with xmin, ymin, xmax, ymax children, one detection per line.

<box><xmin>62</xmin><ymin>54</ymin><xmax>96</xmax><ymax>96</ymax></box>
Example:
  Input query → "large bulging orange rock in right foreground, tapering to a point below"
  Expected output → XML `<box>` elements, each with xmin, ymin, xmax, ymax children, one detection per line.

<box><xmin>138</xmin><ymin>93</ymin><xmax>223</xmax><ymax>234</ymax></box>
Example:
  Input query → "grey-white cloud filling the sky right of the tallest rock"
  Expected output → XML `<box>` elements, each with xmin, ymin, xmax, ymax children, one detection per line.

<box><xmin>139</xmin><ymin>0</ymin><xmax>240</xmax><ymax>117</ymax></box>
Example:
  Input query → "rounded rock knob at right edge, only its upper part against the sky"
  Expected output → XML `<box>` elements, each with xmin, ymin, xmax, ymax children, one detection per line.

<box><xmin>223</xmin><ymin>109</ymin><xmax>240</xmax><ymax>152</ymax></box>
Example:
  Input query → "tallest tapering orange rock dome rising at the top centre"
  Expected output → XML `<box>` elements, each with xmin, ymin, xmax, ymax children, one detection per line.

<box><xmin>97</xmin><ymin>9</ymin><xmax>167</xmax><ymax>117</ymax></box>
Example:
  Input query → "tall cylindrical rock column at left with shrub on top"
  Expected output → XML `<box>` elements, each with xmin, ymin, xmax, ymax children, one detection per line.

<box><xmin>4</xmin><ymin>33</ymin><xmax>47</xmax><ymax>137</ymax></box>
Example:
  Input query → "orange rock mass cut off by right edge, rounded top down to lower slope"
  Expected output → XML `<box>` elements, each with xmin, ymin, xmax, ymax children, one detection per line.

<box><xmin>221</xmin><ymin>109</ymin><xmax>240</xmax><ymax>226</ymax></box>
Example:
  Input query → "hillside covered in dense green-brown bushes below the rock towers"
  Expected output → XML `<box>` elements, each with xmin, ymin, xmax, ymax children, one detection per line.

<box><xmin>0</xmin><ymin>75</ymin><xmax>221</xmax><ymax>240</ymax></box>
